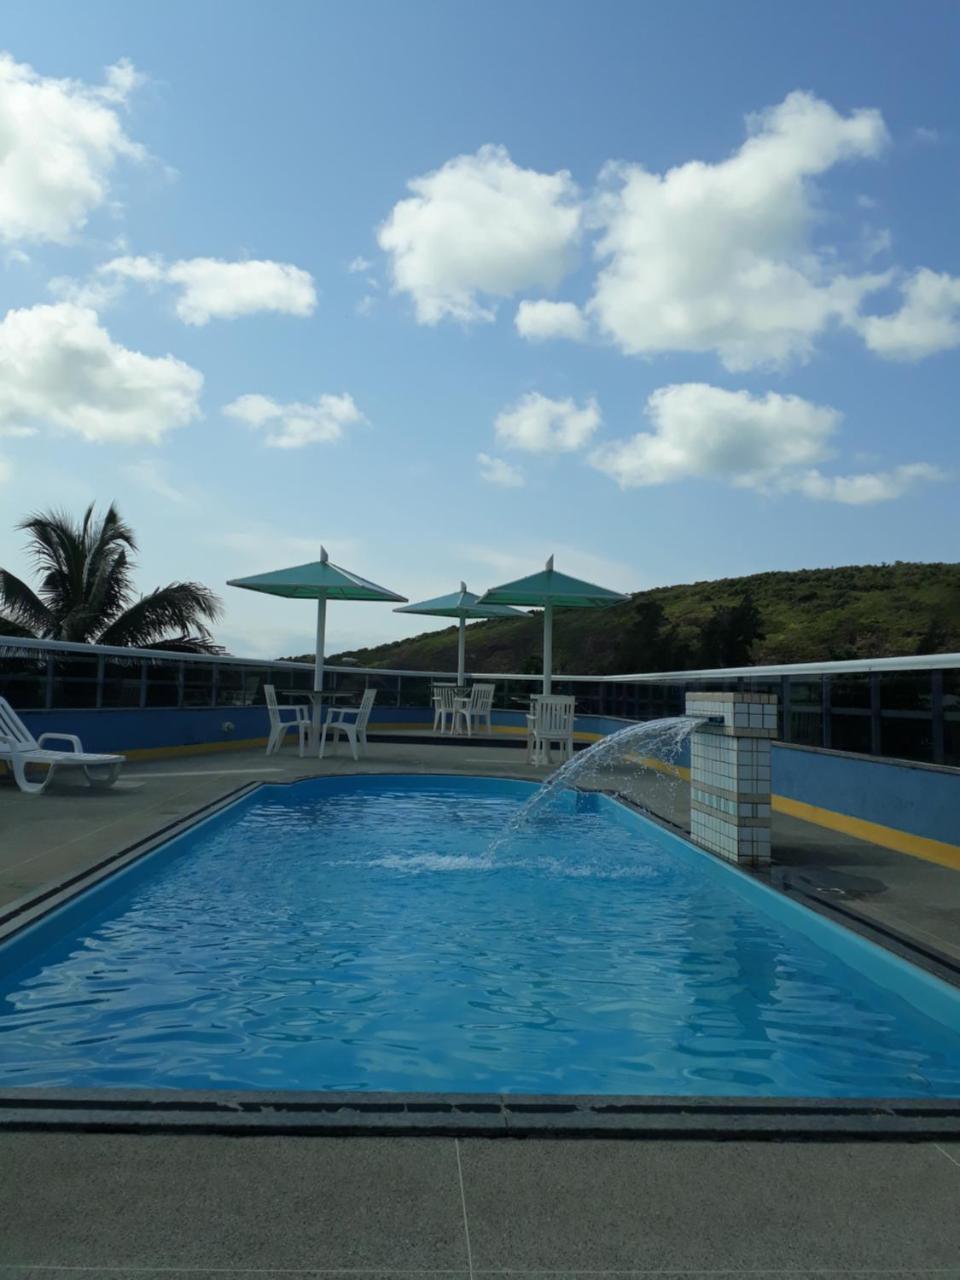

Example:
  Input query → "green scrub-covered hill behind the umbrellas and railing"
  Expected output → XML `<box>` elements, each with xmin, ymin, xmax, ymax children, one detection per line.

<box><xmin>309</xmin><ymin>562</ymin><xmax>960</xmax><ymax>675</ymax></box>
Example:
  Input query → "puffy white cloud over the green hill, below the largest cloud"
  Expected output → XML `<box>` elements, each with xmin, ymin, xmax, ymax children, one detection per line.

<box><xmin>590</xmin><ymin>383</ymin><xmax>841</xmax><ymax>489</ymax></box>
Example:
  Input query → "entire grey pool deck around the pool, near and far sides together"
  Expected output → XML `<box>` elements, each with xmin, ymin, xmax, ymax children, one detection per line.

<box><xmin>0</xmin><ymin>742</ymin><xmax>960</xmax><ymax>1280</ymax></box>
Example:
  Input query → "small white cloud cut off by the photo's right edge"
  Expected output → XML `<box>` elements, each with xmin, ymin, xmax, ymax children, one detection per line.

<box><xmin>858</xmin><ymin>268</ymin><xmax>960</xmax><ymax>360</ymax></box>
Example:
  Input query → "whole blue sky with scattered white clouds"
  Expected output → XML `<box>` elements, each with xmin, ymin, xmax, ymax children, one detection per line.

<box><xmin>0</xmin><ymin>0</ymin><xmax>960</xmax><ymax>654</ymax></box>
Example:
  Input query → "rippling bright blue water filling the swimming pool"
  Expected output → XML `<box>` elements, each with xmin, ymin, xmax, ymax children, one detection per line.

<box><xmin>0</xmin><ymin>777</ymin><xmax>960</xmax><ymax>1097</ymax></box>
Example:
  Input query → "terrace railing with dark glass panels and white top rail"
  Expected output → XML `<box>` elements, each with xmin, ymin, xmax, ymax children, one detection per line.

<box><xmin>0</xmin><ymin>636</ymin><xmax>960</xmax><ymax>767</ymax></box>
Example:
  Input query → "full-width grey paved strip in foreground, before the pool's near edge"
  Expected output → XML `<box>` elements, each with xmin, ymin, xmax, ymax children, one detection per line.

<box><xmin>0</xmin><ymin>1134</ymin><xmax>960</xmax><ymax>1280</ymax></box>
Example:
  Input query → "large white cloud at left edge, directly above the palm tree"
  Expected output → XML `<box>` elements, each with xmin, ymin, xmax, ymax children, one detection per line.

<box><xmin>0</xmin><ymin>302</ymin><xmax>204</xmax><ymax>443</ymax></box>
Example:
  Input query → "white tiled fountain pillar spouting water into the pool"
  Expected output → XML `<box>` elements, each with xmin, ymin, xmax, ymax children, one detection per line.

<box><xmin>686</xmin><ymin>692</ymin><xmax>777</xmax><ymax>867</ymax></box>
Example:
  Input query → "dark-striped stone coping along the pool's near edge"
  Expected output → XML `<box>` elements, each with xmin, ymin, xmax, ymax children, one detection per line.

<box><xmin>0</xmin><ymin>1088</ymin><xmax>960</xmax><ymax>1142</ymax></box>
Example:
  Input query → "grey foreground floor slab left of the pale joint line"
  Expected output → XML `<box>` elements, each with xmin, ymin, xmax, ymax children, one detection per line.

<box><xmin>0</xmin><ymin>1133</ymin><xmax>471</xmax><ymax>1280</ymax></box>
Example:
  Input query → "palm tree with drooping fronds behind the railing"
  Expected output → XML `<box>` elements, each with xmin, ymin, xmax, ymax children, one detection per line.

<box><xmin>0</xmin><ymin>503</ymin><xmax>223</xmax><ymax>653</ymax></box>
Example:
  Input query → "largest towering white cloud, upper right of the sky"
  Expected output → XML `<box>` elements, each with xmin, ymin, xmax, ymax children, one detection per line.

<box><xmin>588</xmin><ymin>92</ymin><xmax>887</xmax><ymax>369</ymax></box>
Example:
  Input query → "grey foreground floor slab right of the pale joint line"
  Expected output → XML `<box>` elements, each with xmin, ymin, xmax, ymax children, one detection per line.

<box><xmin>460</xmin><ymin>1139</ymin><xmax>960</xmax><ymax>1274</ymax></box>
